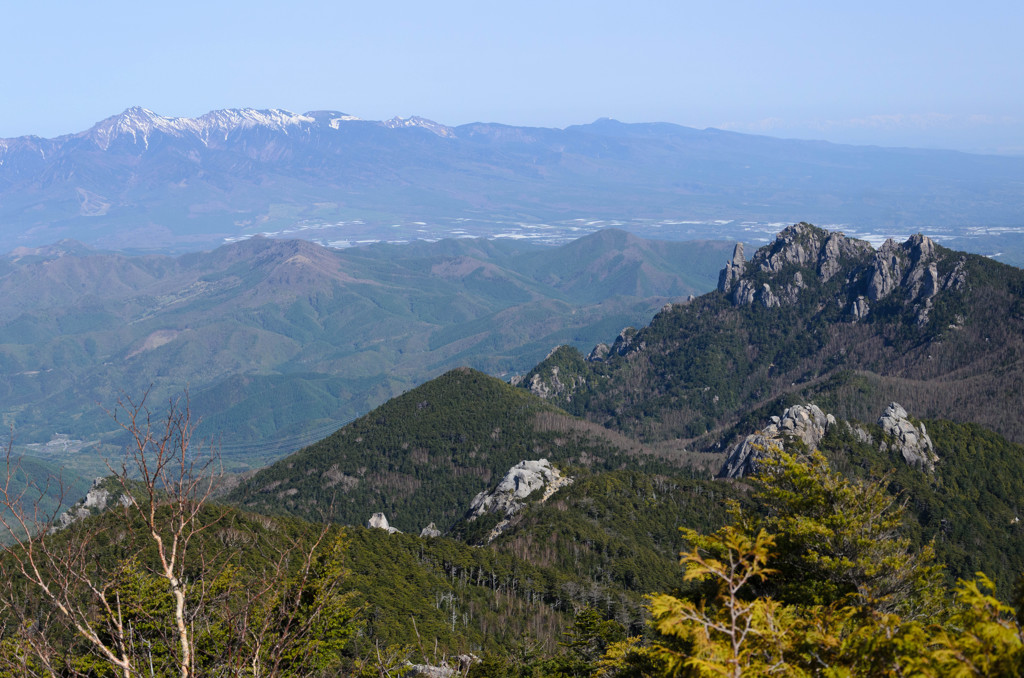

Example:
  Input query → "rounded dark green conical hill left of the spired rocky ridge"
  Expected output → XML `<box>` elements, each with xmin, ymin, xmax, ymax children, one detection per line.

<box><xmin>227</xmin><ymin>369</ymin><xmax>678</xmax><ymax>534</ymax></box>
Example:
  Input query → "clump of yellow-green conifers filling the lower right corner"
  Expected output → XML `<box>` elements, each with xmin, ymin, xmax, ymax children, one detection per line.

<box><xmin>634</xmin><ymin>451</ymin><xmax>1024</xmax><ymax>678</ymax></box>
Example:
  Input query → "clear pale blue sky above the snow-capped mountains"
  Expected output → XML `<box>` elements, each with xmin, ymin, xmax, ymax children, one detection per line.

<box><xmin>0</xmin><ymin>0</ymin><xmax>1024</xmax><ymax>155</ymax></box>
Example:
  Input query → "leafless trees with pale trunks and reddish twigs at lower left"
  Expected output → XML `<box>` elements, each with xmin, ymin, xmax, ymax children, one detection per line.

<box><xmin>0</xmin><ymin>393</ymin><xmax>356</xmax><ymax>678</ymax></box>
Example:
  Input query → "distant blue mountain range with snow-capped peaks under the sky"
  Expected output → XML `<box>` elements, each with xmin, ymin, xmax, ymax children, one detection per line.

<box><xmin>0</xmin><ymin>108</ymin><xmax>1024</xmax><ymax>251</ymax></box>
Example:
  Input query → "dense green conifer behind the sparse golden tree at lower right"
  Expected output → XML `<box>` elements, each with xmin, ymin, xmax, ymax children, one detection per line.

<box><xmin>753</xmin><ymin>450</ymin><xmax>941</xmax><ymax>618</ymax></box>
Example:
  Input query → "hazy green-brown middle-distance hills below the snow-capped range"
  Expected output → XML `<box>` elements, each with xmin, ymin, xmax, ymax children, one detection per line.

<box><xmin>0</xmin><ymin>230</ymin><xmax>731</xmax><ymax>472</ymax></box>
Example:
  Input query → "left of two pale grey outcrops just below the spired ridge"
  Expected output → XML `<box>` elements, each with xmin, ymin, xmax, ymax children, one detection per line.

<box><xmin>722</xmin><ymin>404</ymin><xmax>836</xmax><ymax>478</ymax></box>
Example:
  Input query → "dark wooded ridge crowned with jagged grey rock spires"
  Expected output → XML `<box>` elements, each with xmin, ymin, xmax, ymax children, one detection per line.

<box><xmin>516</xmin><ymin>223</ymin><xmax>1024</xmax><ymax>448</ymax></box>
